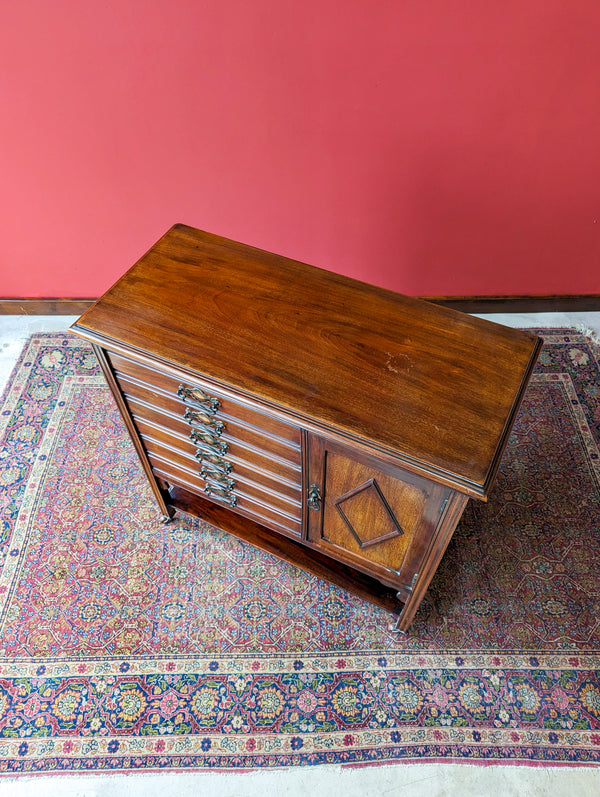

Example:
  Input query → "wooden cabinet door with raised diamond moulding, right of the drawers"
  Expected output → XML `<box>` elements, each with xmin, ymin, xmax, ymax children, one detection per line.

<box><xmin>307</xmin><ymin>435</ymin><xmax>451</xmax><ymax>600</ymax></box>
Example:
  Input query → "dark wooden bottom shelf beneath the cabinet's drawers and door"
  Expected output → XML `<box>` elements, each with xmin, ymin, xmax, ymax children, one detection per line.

<box><xmin>165</xmin><ymin>486</ymin><xmax>403</xmax><ymax>615</ymax></box>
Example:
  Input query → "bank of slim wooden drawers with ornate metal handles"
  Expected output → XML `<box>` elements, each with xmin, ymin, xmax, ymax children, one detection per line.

<box><xmin>108</xmin><ymin>354</ymin><xmax>302</xmax><ymax>537</ymax></box>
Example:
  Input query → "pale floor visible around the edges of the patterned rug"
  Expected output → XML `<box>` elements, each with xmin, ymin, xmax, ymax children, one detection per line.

<box><xmin>0</xmin><ymin>312</ymin><xmax>600</xmax><ymax>797</ymax></box>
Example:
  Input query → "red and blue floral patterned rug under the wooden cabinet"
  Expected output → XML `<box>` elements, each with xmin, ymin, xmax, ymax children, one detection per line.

<box><xmin>0</xmin><ymin>330</ymin><xmax>600</xmax><ymax>773</ymax></box>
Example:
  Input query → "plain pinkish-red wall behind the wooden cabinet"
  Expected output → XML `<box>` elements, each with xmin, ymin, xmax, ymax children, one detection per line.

<box><xmin>0</xmin><ymin>0</ymin><xmax>600</xmax><ymax>297</ymax></box>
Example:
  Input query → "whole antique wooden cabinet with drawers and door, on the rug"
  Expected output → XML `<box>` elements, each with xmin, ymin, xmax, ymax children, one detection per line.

<box><xmin>73</xmin><ymin>225</ymin><xmax>540</xmax><ymax>631</ymax></box>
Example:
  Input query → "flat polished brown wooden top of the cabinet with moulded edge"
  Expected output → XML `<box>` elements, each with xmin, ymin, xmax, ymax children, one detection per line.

<box><xmin>73</xmin><ymin>225</ymin><xmax>540</xmax><ymax>496</ymax></box>
